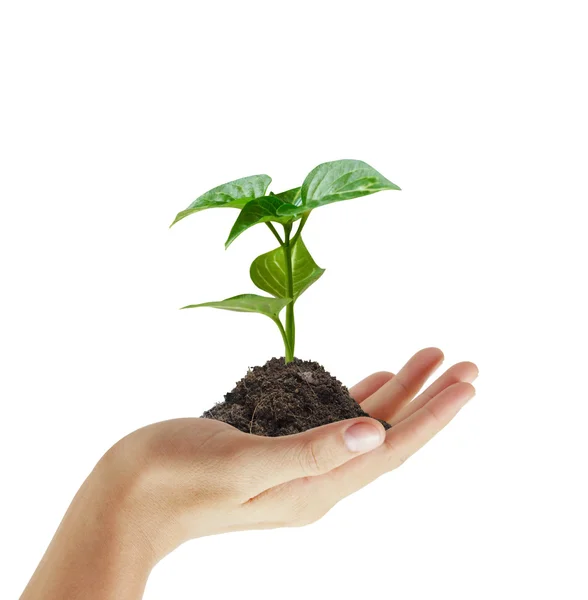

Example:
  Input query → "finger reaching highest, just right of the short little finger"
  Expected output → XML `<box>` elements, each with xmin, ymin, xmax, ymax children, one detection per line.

<box><xmin>362</xmin><ymin>348</ymin><xmax>443</xmax><ymax>421</ymax></box>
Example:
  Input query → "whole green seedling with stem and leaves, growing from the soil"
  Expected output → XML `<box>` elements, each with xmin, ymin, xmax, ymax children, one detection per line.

<box><xmin>170</xmin><ymin>160</ymin><xmax>400</xmax><ymax>362</ymax></box>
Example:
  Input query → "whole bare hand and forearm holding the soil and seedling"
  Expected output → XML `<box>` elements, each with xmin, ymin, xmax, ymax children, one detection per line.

<box><xmin>21</xmin><ymin>348</ymin><xmax>478</xmax><ymax>600</ymax></box>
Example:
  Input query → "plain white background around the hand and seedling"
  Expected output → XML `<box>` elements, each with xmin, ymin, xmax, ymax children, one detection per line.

<box><xmin>0</xmin><ymin>0</ymin><xmax>588</xmax><ymax>600</ymax></box>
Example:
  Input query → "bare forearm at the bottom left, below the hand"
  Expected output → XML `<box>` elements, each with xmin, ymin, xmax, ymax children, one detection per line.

<box><xmin>21</xmin><ymin>454</ymin><xmax>155</xmax><ymax>600</ymax></box>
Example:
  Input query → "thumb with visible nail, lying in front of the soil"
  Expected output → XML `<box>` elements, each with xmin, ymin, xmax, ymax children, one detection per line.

<box><xmin>252</xmin><ymin>417</ymin><xmax>386</xmax><ymax>487</ymax></box>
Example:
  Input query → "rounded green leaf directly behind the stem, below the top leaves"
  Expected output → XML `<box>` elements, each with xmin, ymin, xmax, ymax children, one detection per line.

<box><xmin>249</xmin><ymin>238</ymin><xmax>325</xmax><ymax>302</ymax></box>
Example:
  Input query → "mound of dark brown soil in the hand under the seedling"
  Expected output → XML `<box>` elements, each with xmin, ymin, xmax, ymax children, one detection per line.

<box><xmin>202</xmin><ymin>358</ymin><xmax>390</xmax><ymax>437</ymax></box>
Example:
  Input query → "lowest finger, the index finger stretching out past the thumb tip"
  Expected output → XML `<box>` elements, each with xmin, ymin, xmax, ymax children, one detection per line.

<box><xmin>289</xmin><ymin>382</ymin><xmax>475</xmax><ymax>503</ymax></box>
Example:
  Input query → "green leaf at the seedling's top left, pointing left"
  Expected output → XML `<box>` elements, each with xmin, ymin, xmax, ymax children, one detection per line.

<box><xmin>170</xmin><ymin>175</ymin><xmax>272</xmax><ymax>227</ymax></box>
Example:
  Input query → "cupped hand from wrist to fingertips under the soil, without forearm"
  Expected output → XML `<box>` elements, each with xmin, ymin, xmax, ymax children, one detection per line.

<box><xmin>100</xmin><ymin>348</ymin><xmax>478</xmax><ymax>559</ymax></box>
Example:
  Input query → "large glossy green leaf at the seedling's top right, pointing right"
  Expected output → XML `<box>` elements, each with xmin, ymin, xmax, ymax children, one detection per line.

<box><xmin>280</xmin><ymin>160</ymin><xmax>400</xmax><ymax>215</ymax></box>
